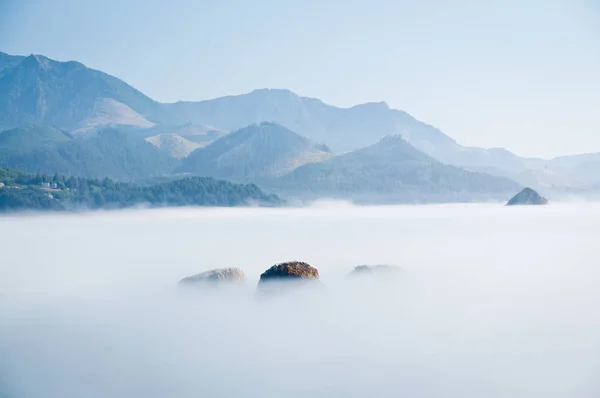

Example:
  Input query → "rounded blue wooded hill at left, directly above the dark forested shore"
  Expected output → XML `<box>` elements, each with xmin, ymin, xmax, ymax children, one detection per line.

<box><xmin>0</xmin><ymin>126</ymin><xmax>177</xmax><ymax>180</ymax></box>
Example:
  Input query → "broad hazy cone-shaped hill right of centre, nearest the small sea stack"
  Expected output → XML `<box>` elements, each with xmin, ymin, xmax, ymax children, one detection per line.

<box><xmin>272</xmin><ymin>136</ymin><xmax>520</xmax><ymax>202</ymax></box>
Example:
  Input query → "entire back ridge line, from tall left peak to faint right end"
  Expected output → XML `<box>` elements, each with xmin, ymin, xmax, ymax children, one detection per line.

<box><xmin>0</xmin><ymin>53</ymin><xmax>600</xmax><ymax>194</ymax></box>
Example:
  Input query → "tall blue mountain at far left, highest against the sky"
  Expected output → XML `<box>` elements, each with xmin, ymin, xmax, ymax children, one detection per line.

<box><xmin>0</xmin><ymin>55</ymin><xmax>164</xmax><ymax>130</ymax></box>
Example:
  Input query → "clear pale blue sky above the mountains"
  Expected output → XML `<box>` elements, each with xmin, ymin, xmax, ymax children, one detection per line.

<box><xmin>0</xmin><ymin>0</ymin><xmax>600</xmax><ymax>157</ymax></box>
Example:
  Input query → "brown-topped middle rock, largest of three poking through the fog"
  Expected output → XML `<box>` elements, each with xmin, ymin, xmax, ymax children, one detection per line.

<box><xmin>258</xmin><ymin>261</ymin><xmax>319</xmax><ymax>291</ymax></box>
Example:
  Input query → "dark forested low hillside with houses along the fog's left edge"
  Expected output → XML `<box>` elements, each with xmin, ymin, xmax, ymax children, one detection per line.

<box><xmin>0</xmin><ymin>169</ymin><xmax>282</xmax><ymax>212</ymax></box>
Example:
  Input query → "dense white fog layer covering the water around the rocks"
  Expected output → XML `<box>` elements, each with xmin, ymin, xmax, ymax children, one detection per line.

<box><xmin>0</xmin><ymin>204</ymin><xmax>600</xmax><ymax>398</ymax></box>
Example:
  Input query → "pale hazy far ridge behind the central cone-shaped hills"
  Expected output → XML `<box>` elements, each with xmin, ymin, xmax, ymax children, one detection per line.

<box><xmin>165</xmin><ymin>89</ymin><xmax>540</xmax><ymax>179</ymax></box>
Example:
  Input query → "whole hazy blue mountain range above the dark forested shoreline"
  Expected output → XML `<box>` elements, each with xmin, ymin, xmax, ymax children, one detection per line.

<box><xmin>0</xmin><ymin>53</ymin><xmax>600</xmax><ymax>200</ymax></box>
